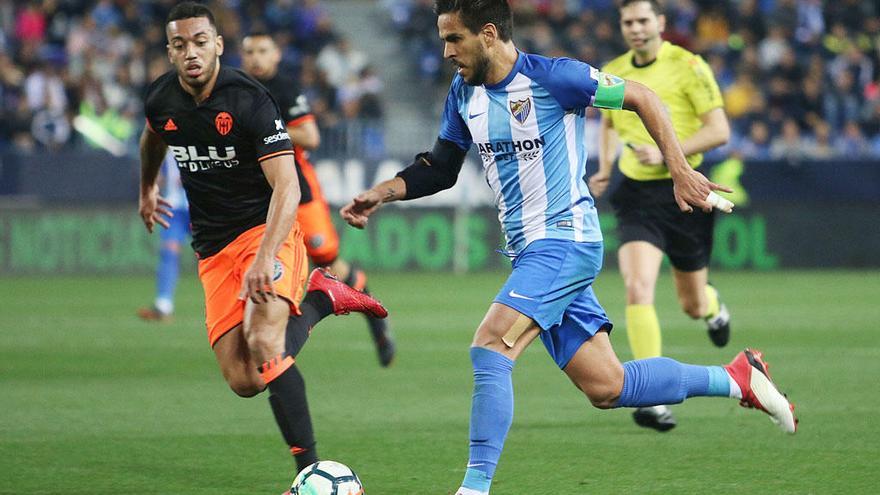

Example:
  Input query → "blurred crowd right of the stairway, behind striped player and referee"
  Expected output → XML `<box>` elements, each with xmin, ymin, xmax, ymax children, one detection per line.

<box><xmin>396</xmin><ymin>0</ymin><xmax>880</xmax><ymax>160</ymax></box>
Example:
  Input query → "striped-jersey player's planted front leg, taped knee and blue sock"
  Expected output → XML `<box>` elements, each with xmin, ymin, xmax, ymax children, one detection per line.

<box><xmin>457</xmin><ymin>303</ymin><xmax>540</xmax><ymax>495</ymax></box>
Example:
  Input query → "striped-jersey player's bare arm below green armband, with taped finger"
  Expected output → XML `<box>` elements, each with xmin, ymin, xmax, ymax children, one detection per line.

<box><xmin>623</xmin><ymin>81</ymin><xmax>733</xmax><ymax>213</ymax></box>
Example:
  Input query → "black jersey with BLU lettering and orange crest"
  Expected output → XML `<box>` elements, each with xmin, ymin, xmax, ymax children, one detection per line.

<box><xmin>144</xmin><ymin>67</ymin><xmax>293</xmax><ymax>258</ymax></box>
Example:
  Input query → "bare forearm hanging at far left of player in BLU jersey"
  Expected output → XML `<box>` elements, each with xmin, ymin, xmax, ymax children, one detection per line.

<box><xmin>138</xmin><ymin>125</ymin><xmax>173</xmax><ymax>234</ymax></box>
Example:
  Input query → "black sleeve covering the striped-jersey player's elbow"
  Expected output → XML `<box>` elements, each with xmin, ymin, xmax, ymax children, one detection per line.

<box><xmin>397</xmin><ymin>138</ymin><xmax>467</xmax><ymax>199</ymax></box>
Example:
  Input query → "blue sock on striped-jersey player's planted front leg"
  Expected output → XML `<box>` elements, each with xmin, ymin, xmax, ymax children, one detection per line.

<box><xmin>461</xmin><ymin>347</ymin><xmax>513</xmax><ymax>492</ymax></box>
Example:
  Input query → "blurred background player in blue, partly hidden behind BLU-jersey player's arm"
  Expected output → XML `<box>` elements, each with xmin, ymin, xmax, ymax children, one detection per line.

<box><xmin>138</xmin><ymin>153</ymin><xmax>192</xmax><ymax>321</ymax></box>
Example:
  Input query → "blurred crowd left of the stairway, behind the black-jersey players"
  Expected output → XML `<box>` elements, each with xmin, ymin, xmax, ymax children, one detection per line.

<box><xmin>0</xmin><ymin>0</ymin><xmax>383</xmax><ymax>154</ymax></box>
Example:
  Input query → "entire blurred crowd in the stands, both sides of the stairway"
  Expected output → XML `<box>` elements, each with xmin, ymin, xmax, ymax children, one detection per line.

<box><xmin>0</xmin><ymin>0</ymin><xmax>880</xmax><ymax>160</ymax></box>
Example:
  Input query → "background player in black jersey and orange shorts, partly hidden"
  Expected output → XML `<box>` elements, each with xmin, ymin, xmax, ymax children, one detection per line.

<box><xmin>241</xmin><ymin>33</ymin><xmax>395</xmax><ymax>366</ymax></box>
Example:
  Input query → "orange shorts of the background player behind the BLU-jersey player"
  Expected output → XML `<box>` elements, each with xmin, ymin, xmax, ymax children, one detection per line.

<box><xmin>296</xmin><ymin>160</ymin><xmax>339</xmax><ymax>266</ymax></box>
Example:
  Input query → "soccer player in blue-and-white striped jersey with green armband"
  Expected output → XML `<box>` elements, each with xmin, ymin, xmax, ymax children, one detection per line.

<box><xmin>340</xmin><ymin>0</ymin><xmax>796</xmax><ymax>495</ymax></box>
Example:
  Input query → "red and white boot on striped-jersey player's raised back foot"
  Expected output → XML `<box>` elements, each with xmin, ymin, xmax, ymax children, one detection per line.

<box><xmin>724</xmin><ymin>349</ymin><xmax>798</xmax><ymax>433</ymax></box>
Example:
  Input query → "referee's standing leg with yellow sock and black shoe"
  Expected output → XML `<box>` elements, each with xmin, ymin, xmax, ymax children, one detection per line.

<box><xmin>617</xmin><ymin>241</ymin><xmax>676</xmax><ymax>431</ymax></box>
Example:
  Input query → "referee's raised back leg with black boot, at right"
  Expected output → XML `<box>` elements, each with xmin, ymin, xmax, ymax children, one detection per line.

<box><xmin>672</xmin><ymin>268</ymin><xmax>730</xmax><ymax>347</ymax></box>
